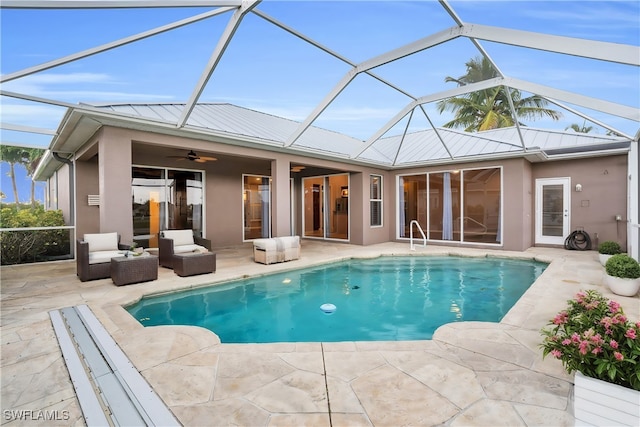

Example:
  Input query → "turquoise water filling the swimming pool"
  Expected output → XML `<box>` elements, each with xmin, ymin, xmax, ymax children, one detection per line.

<box><xmin>127</xmin><ymin>257</ymin><xmax>547</xmax><ymax>343</ymax></box>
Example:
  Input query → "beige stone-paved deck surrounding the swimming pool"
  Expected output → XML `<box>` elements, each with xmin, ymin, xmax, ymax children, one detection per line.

<box><xmin>0</xmin><ymin>240</ymin><xmax>640</xmax><ymax>426</ymax></box>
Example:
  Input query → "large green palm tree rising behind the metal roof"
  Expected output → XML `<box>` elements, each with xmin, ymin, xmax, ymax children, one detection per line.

<box><xmin>437</xmin><ymin>57</ymin><xmax>562</xmax><ymax>132</ymax></box>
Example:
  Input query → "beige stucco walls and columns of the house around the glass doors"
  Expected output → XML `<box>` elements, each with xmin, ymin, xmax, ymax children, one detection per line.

<box><xmin>66</xmin><ymin>127</ymin><xmax>627</xmax><ymax>256</ymax></box>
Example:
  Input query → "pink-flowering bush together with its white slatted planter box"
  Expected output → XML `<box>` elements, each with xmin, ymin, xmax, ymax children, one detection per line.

<box><xmin>541</xmin><ymin>290</ymin><xmax>640</xmax><ymax>426</ymax></box>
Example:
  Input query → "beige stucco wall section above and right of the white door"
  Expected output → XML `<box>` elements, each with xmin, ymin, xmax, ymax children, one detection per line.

<box><xmin>533</xmin><ymin>155</ymin><xmax>628</xmax><ymax>249</ymax></box>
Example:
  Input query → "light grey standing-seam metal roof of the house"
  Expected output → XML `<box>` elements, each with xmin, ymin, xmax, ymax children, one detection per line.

<box><xmin>86</xmin><ymin>103</ymin><xmax>628</xmax><ymax>167</ymax></box>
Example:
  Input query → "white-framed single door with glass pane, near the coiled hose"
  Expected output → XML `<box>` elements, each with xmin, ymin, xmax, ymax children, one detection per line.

<box><xmin>536</xmin><ymin>178</ymin><xmax>571</xmax><ymax>245</ymax></box>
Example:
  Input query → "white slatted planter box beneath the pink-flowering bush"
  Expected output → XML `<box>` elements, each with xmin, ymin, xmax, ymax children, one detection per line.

<box><xmin>574</xmin><ymin>372</ymin><xmax>640</xmax><ymax>427</ymax></box>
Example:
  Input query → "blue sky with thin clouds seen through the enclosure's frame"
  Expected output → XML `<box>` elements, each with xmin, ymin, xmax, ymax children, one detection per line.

<box><xmin>0</xmin><ymin>0</ymin><xmax>640</xmax><ymax>147</ymax></box>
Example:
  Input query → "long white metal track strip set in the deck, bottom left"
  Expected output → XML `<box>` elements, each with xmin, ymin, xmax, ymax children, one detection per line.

<box><xmin>49</xmin><ymin>305</ymin><xmax>180</xmax><ymax>426</ymax></box>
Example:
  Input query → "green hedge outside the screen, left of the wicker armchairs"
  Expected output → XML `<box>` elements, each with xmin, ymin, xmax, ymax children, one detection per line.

<box><xmin>0</xmin><ymin>205</ymin><xmax>71</xmax><ymax>265</ymax></box>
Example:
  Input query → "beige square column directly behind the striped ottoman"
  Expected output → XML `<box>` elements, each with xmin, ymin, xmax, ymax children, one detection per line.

<box><xmin>271</xmin><ymin>159</ymin><xmax>291</xmax><ymax>237</ymax></box>
